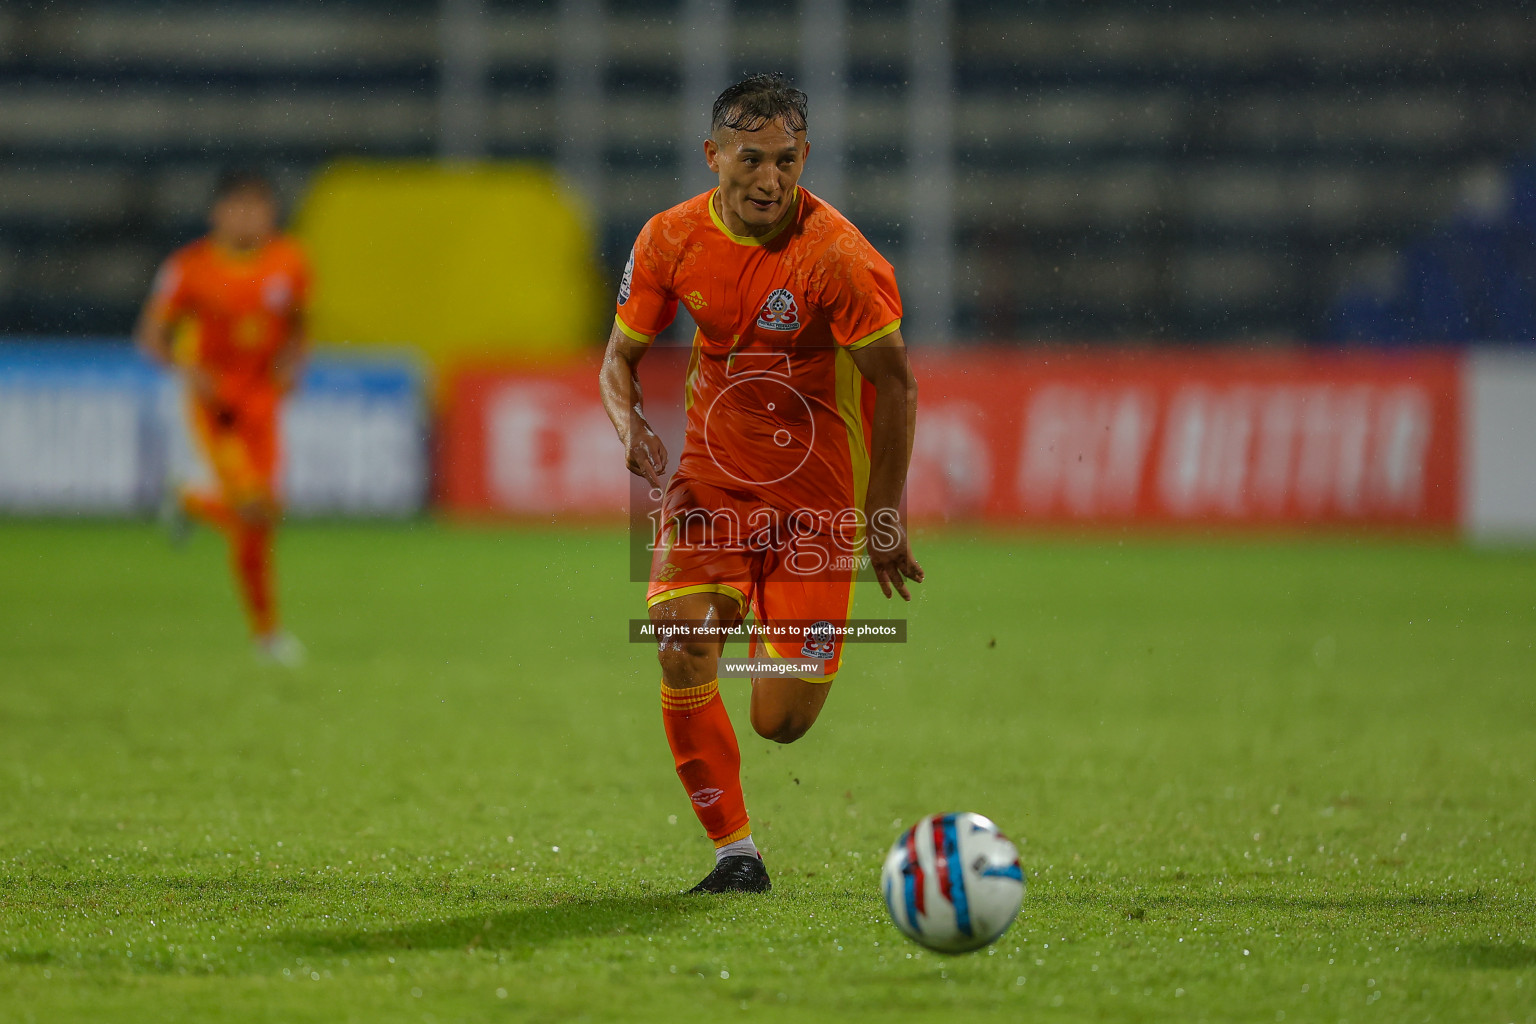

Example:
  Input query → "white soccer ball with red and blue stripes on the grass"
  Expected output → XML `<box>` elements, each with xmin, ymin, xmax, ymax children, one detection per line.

<box><xmin>880</xmin><ymin>814</ymin><xmax>1025</xmax><ymax>953</ymax></box>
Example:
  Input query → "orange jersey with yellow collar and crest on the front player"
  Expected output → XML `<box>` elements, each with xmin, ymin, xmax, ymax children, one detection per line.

<box><xmin>617</xmin><ymin>189</ymin><xmax>902</xmax><ymax>530</ymax></box>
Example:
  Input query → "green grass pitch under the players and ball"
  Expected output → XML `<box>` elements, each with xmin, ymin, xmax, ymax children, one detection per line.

<box><xmin>0</xmin><ymin>522</ymin><xmax>1536</xmax><ymax>1024</ymax></box>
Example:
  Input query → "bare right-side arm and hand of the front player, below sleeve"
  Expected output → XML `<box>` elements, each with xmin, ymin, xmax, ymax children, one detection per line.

<box><xmin>851</xmin><ymin>330</ymin><xmax>923</xmax><ymax>600</ymax></box>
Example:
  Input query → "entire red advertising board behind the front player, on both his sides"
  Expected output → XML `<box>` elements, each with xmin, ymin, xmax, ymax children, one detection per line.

<box><xmin>439</xmin><ymin>350</ymin><xmax>1462</xmax><ymax>528</ymax></box>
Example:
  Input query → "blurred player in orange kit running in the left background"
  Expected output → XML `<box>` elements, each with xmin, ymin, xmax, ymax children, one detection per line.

<box><xmin>135</xmin><ymin>172</ymin><xmax>309</xmax><ymax>666</ymax></box>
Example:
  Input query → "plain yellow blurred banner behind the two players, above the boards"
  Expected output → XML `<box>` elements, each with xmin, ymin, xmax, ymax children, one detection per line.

<box><xmin>295</xmin><ymin>161</ymin><xmax>611</xmax><ymax>365</ymax></box>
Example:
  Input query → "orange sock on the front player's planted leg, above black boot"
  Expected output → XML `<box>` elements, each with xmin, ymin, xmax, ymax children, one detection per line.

<box><xmin>662</xmin><ymin>680</ymin><xmax>753</xmax><ymax>847</ymax></box>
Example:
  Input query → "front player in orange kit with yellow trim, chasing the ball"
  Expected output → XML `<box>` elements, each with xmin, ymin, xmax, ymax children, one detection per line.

<box><xmin>601</xmin><ymin>75</ymin><xmax>923</xmax><ymax>894</ymax></box>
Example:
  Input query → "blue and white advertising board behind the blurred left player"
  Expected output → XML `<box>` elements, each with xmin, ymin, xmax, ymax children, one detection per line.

<box><xmin>0</xmin><ymin>339</ymin><xmax>429</xmax><ymax>516</ymax></box>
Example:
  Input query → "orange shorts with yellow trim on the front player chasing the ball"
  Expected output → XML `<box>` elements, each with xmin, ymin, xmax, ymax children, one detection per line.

<box><xmin>645</xmin><ymin>477</ymin><xmax>862</xmax><ymax>683</ymax></box>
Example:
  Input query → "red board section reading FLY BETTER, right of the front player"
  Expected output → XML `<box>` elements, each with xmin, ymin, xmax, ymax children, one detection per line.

<box><xmin>908</xmin><ymin>353</ymin><xmax>1461</xmax><ymax>527</ymax></box>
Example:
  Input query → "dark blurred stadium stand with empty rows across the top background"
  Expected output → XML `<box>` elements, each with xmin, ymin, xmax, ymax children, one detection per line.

<box><xmin>0</xmin><ymin>0</ymin><xmax>1536</xmax><ymax>341</ymax></box>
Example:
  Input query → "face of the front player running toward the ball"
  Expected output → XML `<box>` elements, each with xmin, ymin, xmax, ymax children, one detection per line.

<box><xmin>703</xmin><ymin>120</ymin><xmax>811</xmax><ymax>235</ymax></box>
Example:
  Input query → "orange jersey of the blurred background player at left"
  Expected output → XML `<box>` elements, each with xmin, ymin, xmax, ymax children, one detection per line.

<box><xmin>152</xmin><ymin>235</ymin><xmax>309</xmax><ymax>398</ymax></box>
